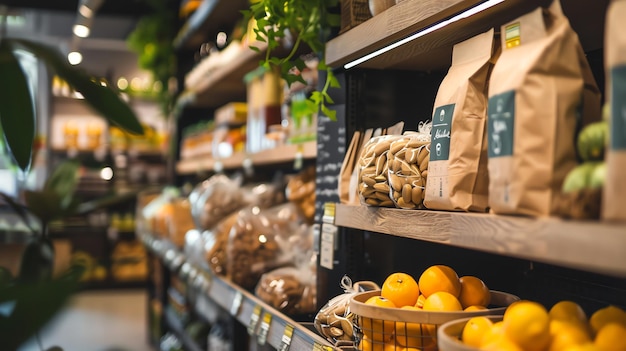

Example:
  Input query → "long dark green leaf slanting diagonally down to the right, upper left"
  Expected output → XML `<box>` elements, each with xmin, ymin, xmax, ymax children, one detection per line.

<box><xmin>3</xmin><ymin>39</ymin><xmax>143</xmax><ymax>135</ymax></box>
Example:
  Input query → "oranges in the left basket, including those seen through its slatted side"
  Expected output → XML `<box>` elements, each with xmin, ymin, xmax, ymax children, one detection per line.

<box><xmin>359</xmin><ymin>265</ymin><xmax>491</xmax><ymax>351</ymax></box>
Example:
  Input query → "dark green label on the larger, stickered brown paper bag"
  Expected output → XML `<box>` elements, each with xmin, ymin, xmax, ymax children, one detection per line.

<box><xmin>486</xmin><ymin>90</ymin><xmax>515</xmax><ymax>158</ymax></box>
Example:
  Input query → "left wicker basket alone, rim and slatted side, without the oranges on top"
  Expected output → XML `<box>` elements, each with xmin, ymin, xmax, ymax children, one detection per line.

<box><xmin>350</xmin><ymin>290</ymin><xmax>519</xmax><ymax>351</ymax></box>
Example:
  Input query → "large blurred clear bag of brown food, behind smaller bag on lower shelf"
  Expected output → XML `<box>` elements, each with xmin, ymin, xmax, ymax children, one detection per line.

<box><xmin>226</xmin><ymin>203</ymin><xmax>302</xmax><ymax>290</ymax></box>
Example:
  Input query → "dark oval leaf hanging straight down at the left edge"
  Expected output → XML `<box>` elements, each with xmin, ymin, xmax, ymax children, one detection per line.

<box><xmin>0</xmin><ymin>40</ymin><xmax>35</xmax><ymax>170</ymax></box>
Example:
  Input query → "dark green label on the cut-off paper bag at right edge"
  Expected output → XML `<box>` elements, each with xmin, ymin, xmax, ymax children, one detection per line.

<box><xmin>610</xmin><ymin>65</ymin><xmax>626</xmax><ymax>150</ymax></box>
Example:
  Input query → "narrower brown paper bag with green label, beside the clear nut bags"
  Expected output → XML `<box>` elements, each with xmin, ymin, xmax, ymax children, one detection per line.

<box><xmin>424</xmin><ymin>29</ymin><xmax>499</xmax><ymax>212</ymax></box>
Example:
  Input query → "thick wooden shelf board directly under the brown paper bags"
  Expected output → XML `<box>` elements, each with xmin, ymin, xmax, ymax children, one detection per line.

<box><xmin>335</xmin><ymin>204</ymin><xmax>626</xmax><ymax>277</ymax></box>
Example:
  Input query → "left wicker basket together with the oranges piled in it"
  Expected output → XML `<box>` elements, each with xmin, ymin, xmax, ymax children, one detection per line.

<box><xmin>350</xmin><ymin>265</ymin><xmax>519</xmax><ymax>351</ymax></box>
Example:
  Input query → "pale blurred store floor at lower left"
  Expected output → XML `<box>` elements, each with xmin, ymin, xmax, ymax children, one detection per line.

<box><xmin>19</xmin><ymin>290</ymin><xmax>152</xmax><ymax>351</ymax></box>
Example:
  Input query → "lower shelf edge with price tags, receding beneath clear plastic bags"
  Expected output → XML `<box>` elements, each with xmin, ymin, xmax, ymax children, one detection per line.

<box><xmin>141</xmin><ymin>233</ymin><xmax>334</xmax><ymax>351</ymax></box>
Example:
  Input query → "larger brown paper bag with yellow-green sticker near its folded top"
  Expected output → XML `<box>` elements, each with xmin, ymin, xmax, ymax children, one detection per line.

<box><xmin>487</xmin><ymin>0</ymin><xmax>600</xmax><ymax>216</ymax></box>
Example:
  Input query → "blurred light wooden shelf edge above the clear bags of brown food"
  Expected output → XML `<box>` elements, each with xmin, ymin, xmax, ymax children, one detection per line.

<box><xmin>176</xmin><ymin>141</ymin><xmax>317</xmax><ymax>174</ymax></box>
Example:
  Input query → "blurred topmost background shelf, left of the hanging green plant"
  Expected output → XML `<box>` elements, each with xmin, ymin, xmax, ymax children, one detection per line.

<box><xmin>174</xmin><ymin>0</ymin><xmax>250</xmax><ymax>50</ymax></box>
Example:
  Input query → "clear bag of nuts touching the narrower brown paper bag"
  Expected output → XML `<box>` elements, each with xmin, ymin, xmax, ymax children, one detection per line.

<box><xmin>387</xmin><ymin>128</ymin><xmax>430</xmax><ymax>209</ymax></box>
